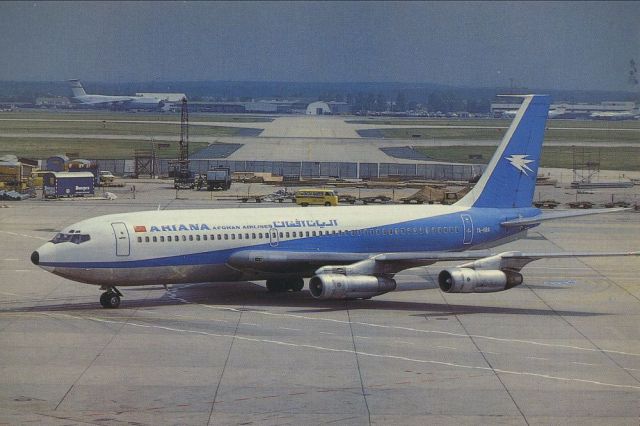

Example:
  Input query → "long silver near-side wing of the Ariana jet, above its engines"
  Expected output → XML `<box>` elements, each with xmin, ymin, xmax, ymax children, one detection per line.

<box><xmin>227</xmin><ymin>249</ymin><xmax>640</xmax><ymax>275</ymax></box>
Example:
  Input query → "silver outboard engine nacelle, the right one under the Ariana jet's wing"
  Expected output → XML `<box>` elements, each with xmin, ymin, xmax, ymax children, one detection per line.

<box><xmin>438</xmin><ymin>268</ymin><xmax>522</xmax><ymax>293</ymax></box>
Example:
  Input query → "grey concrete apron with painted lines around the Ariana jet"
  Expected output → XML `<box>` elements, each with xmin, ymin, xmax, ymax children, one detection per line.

<box><xmin>0</xmin><ymin>185</ymin><xmax>640</xmax><ymax>425</ymax></box>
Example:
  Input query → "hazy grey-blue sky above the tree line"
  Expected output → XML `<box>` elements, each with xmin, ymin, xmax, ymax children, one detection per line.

<box><xmin>0</xmin><ymin>1</ymin><xmax>640</xmax><ymax>90</ymax></box>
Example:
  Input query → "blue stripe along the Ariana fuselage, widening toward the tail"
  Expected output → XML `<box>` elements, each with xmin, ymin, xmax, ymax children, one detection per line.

<box><xmin>40</xmin><ymin>208</ymin><xmax>539</xmax><ymax>268</ymax></box>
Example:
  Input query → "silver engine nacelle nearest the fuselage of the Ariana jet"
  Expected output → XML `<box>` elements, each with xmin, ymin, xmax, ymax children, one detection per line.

<box><xmin>309</xmin><ymin>274</ymin><xmax>396</xmax><ymax>299</ymax></box>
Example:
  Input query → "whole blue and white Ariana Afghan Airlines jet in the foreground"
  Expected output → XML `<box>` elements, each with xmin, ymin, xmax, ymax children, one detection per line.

<box><xmin>31</xmin><ymin>95</ymin><xmax>640</xmax><ymax>308</ymax></box>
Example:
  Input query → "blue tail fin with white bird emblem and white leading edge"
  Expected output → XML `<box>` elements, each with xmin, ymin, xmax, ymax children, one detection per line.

<box><xmin>456</xmin><ymin>95</ymin><xmax>550</xmax><ymax>208</ymax></box>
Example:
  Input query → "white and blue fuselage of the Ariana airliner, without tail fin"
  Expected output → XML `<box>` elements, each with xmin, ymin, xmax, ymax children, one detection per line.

<box><xmin>33</xmin><ymin>206</ymin><xmax>537</xmax><ymax>286</ymax></box>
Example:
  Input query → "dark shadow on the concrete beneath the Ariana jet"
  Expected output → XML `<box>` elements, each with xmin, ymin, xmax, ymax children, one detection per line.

<box><xmin>0</xmin><ymin>281</ymin><xmax>608</xmax><ymax>317</ymax></box>
